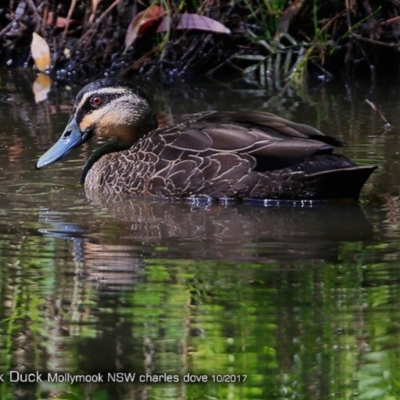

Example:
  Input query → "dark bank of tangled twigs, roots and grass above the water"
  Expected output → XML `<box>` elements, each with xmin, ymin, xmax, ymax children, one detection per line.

<box><xmin>0</xmin><ymin>0</ymin><xmax>400</xmax><ymax>86</ymax></box>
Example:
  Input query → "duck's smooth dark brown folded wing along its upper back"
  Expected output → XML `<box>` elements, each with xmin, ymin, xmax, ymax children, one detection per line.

<box><xmin>169</xmin><ymin>111</ymin><xmax>343</xmax><ymax>171</ymax></box>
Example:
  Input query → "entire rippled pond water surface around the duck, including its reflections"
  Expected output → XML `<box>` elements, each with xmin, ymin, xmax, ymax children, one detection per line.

<box><xmin>0</xmin><ymin>72</ymin><xmax>400</xmax><ymax>400</ymax></box>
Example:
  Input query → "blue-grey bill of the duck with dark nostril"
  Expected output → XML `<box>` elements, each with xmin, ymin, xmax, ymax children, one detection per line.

<box><xmin>36</xmin><ymin>118</ymin><xmax>90</xmax><ymax>169</ymax></box>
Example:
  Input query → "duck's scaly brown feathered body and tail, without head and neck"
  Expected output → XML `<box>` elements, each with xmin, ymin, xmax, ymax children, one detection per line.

<box><xmin>85</xmin><ymin>111</ymin><xmax>375</xmax><ymax>200</ymax></box>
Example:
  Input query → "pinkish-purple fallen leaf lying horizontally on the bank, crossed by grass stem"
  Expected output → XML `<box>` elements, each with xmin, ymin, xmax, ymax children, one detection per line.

<box><xmin>157</xmin><ymin>13</ymin><xmax>231</xmax><ymax>33</ymax></box>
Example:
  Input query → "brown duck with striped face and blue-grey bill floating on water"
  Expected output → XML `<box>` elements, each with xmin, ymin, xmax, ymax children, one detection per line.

<box><xmin>36</xmin><ymin>78</ymin><xmax>376</xmax><ymax>200</ymax></box>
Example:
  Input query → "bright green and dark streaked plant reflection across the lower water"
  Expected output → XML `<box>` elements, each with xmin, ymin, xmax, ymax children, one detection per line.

<box><xmin>0</xmin><ymin>238</ymin><xmax>399</xmax><ymax>399</ymax></box>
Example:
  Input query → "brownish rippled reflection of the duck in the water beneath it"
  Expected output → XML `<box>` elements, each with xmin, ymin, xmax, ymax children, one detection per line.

<box><xmin>41</xmin><ymin>196</ymin><xmax>373</xmax><ymax>290</ymax></box>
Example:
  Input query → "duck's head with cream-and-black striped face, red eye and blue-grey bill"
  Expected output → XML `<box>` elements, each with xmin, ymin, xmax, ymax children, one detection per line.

<box><xmin>36</xmin><ymin>78</ymin><xmax>157</xmax><ymax>169</ymax></box>
